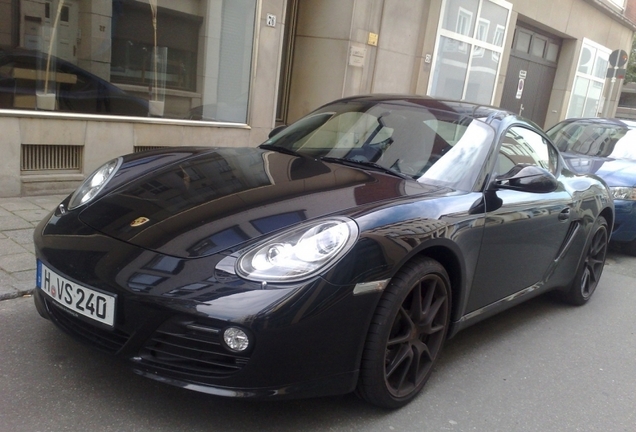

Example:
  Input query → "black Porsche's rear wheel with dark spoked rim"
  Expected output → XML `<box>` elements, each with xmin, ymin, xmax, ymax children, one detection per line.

<box><xmin>566</xmin><ymin>216</ymin><xmax>609</xmax><ymax>306</ymax></box>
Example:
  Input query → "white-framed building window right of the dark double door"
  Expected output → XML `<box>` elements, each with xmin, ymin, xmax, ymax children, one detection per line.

<box><xmin>567</xmin><ymin>39</ymin><xmax>611</xmax><ymax>118</ymax></box>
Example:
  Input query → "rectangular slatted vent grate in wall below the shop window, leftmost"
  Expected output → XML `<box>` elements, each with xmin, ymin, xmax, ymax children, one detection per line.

<box><xmin>20</xmin><ymin>144</ymin><xmax>82</xmax><ymax>171</ymax></box>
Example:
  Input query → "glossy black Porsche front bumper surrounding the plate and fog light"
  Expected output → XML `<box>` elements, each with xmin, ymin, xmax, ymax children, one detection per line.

<box><xmin>34</xmin><ymin>251</ymin><xmax>377</xmax><ymax>398</ymax></box>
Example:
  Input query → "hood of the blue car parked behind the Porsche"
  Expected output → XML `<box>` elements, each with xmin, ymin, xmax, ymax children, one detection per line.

<box><xmin>563</xmin><ymin>153</ymin><xmax>636</xmax><ymax>187</ymax></box>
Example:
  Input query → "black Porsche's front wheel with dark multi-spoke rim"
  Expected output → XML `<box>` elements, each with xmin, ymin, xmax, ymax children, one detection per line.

<box><xmin>357</xmin><ymin>258</ymin><xmax>451</xmax><ymax>409</ymax></box>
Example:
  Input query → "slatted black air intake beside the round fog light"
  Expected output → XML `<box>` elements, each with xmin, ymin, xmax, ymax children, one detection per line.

<box><xmin>140</xmin><ymin>320</ymin><xmax>249</xmax><ymax>379</ymax></box>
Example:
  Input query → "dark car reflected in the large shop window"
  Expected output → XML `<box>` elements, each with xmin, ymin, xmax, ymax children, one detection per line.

<box><xmin>0</xmin><ymin>49</ymin><xmax>148</xmax><ymax>117</ymax></box>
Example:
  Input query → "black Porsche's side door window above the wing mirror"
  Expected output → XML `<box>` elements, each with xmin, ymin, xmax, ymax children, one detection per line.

<box><xmin>497</xmin><ymin>126</ymin><xmax>558</xmax><ymax>174</ymax></box>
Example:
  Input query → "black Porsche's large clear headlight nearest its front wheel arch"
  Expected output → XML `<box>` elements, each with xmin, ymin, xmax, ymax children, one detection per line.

<box><xmin>236</xmin><ymin>218</ymin><xmax>358</xmax><ymax>282</ymax></box>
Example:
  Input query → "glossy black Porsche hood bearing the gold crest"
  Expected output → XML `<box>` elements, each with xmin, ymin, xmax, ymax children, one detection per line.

<box><xmin>80</xmin><ymin>148</ymin><xmax>438</xmax><ymax>258</ymax></box>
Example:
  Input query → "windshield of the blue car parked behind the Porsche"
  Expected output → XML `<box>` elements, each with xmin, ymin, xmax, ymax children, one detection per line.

<box><xmin>548</xmin><ymin>121</ymin><xmax>636</xmax><ymax>160</ymax></box>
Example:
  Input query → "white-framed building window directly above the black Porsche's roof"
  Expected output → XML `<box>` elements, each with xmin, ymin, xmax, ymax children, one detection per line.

<box><xmin>428</xmin><ymin>0</ymin><xmax>512</xmax><ymax>104</ymax></box>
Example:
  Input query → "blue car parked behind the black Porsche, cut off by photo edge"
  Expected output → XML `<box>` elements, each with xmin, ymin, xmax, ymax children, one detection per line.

<box><xmin>548</xmin><ymin>118</ymin><xmax>636</xmax><ymax>255</ymax></box>
